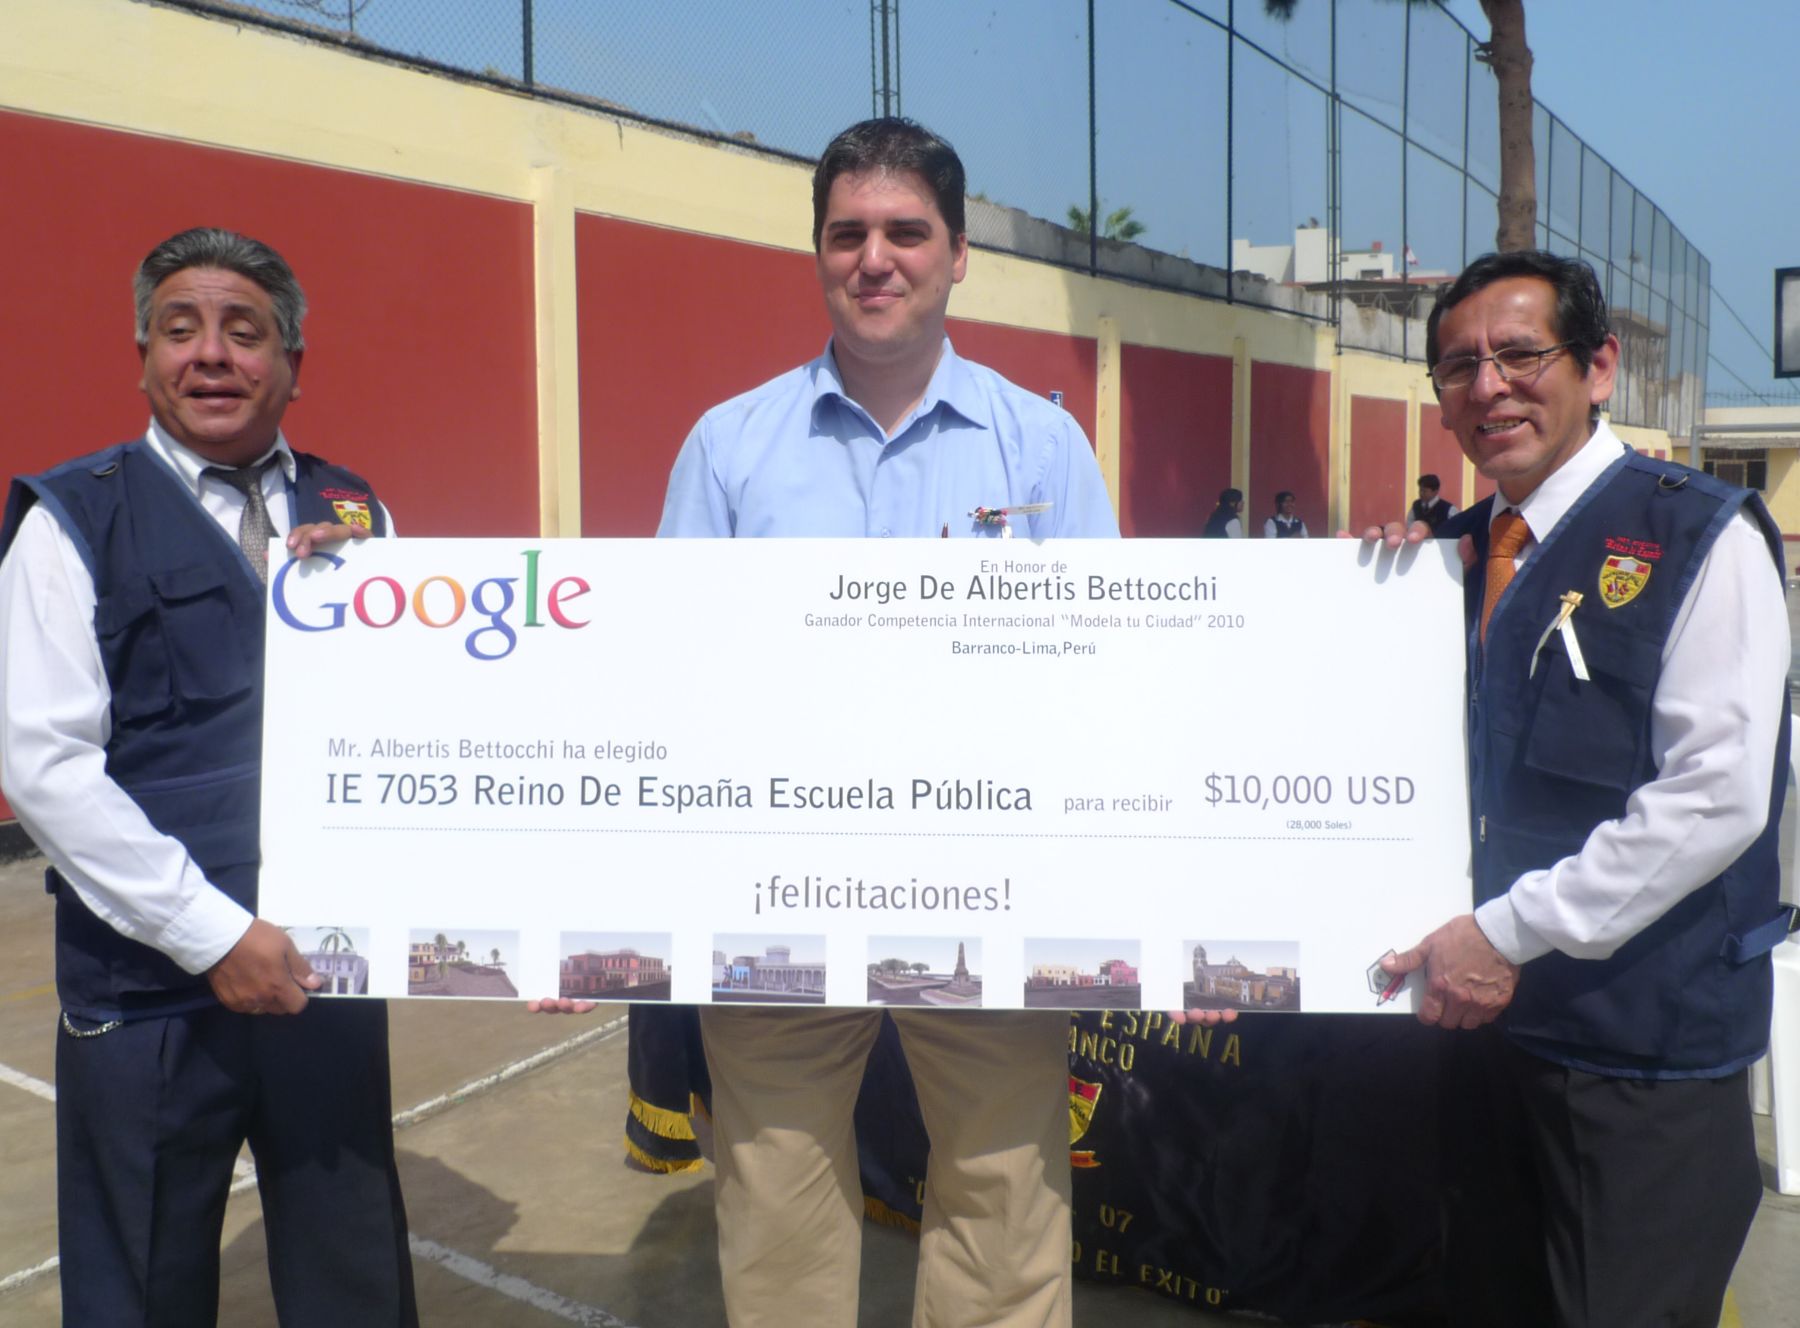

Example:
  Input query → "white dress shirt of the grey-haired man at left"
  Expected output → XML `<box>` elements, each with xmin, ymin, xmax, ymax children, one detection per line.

<box><xmin>0</xmin><ymin>423</ymin><xmax>392</xmax><ymax>974</ymax></box>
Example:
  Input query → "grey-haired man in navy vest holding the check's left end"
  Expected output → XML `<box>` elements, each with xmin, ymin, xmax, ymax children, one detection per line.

<box><xmin>0</xmin><ymin>229</ymin><xmax>418</xmax><ymax>1328</ymax></box>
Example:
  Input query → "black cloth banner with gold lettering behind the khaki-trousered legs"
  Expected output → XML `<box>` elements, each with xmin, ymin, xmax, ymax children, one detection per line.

<box><xmin>626</xmin><ymin>1006</ymin><xmax>1444</xmax><ymax>1328</ymax></box>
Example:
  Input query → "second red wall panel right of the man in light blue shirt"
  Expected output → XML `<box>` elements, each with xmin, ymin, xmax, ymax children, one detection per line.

<box><xmin>1120</xmin><ymin>345</ymin><xmax>1231</xmax><ymax>536</ymax></box>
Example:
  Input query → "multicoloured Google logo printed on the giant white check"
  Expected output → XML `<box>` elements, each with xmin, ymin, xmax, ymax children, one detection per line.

<box><xmin>270</xmin><ymin>549</ymin><xmax>592</xmax><ymax>660</ymax></box>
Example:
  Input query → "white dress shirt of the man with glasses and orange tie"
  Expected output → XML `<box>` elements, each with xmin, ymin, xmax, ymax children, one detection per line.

<box><xmin>1474</xmin><ymin>423</ymin><xmax>1791</xmax><ymax>965</ymax></box>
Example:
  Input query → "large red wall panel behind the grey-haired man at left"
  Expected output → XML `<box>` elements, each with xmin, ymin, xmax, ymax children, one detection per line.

<box><xmin>0</xmin><ymin>112</ymin><xmax>538</xmax><ymax>534</ymax></box>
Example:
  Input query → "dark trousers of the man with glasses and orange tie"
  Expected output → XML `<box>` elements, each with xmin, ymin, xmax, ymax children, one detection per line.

<box><xmin>1442</xmin><ymin>1027</ymin><xmax>1762</xmax><ymax>1328</ymax></box>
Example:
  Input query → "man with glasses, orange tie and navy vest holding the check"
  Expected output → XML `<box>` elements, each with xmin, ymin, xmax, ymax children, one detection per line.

<box><xmin>1372</xmin><ymin>252</ymin><xmax>1789</xmax><ymax>1328</ymax></box>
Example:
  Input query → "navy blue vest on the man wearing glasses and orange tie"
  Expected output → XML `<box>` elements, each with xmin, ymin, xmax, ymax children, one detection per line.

<box><xmin>1440</xmin><ymin>452</ymin><xmax>1787</xmax><ymax>1078</ymax></box>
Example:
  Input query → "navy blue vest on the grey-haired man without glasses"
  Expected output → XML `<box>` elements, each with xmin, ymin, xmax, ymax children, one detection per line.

<box><xmin>0</xmin><ymin>441</ymin><xmax>387</xmax><ymax>1020</ymax></box>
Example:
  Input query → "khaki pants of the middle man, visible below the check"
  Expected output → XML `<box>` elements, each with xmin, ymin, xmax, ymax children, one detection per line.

<box><xmin>700</xmin><ymin>1006</ymin><xmax>1069</xmax><ymax>1328</ymax></box>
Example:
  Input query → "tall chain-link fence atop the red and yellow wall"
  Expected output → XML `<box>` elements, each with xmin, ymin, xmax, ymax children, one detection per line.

<box><xmin>164</xmin><ymin>0</ymin><xmax>1710</xmax><ymax>437</ymax></box>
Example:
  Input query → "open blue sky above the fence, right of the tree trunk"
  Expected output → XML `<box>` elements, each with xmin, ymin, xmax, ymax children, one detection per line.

<box><xmin>1449</xmin><ymin>0</ymin><xmax>1800</xmax><ymax>399</ymax></box>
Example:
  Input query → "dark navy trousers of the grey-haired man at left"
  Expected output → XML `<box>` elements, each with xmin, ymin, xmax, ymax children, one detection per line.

<box><xmin>56</xmin><ymin>1000</ymin><xmax>418</xmax><ymax>1328</ymax></box>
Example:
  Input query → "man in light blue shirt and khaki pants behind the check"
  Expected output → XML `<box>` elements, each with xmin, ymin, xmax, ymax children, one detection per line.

<box><xmin>657</xmin><ymin>119</ymin><xmax>1118</xmax><ymax>1328</ymax></box>
